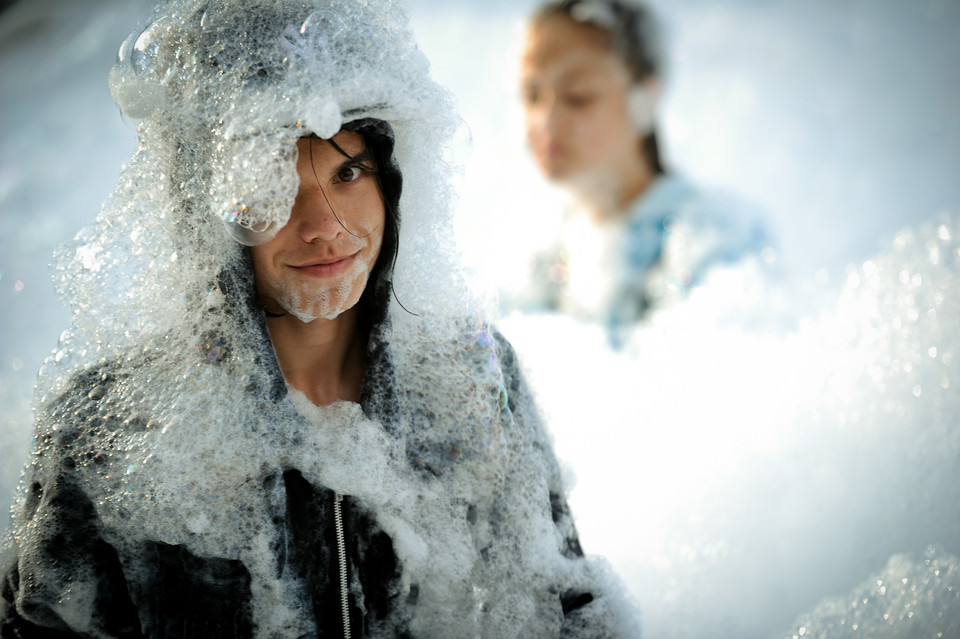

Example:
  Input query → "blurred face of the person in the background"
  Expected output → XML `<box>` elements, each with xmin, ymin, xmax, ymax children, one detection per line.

<box><xmin>521</xmin><ymin>16</ymin><xmax>639</xmax><ymax>182</ymax></box>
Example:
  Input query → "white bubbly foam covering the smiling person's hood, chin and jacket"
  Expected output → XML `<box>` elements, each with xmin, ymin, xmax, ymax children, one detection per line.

<box><xmin>7</xmin><ymin>0</ymin><xmax>630</xmax><ymax>637</ymax></box>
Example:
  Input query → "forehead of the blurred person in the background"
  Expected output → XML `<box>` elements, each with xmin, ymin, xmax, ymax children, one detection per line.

<box><xmin>521</xmin><ymin>16</ymin><xmax>629</xmax><ymax>83</ymax></box>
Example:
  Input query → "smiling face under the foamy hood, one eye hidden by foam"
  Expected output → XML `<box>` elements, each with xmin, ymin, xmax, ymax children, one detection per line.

<box><xmin>250</xmin><ymin>131</ymin><xmax>384</xmax><ymax>322</ymax></box>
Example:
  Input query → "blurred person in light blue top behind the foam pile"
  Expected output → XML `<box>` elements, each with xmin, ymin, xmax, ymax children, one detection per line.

<box><xmin>506</xmin><ymin>0</ymin><xmax>772</xmax><ymax>341</ymax></box>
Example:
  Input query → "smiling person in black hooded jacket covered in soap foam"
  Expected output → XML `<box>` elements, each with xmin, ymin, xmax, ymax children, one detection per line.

<box><xmin>0</xmin><ymin>0</ymin><xmax>637</xmax><ymax>637</ymax></box>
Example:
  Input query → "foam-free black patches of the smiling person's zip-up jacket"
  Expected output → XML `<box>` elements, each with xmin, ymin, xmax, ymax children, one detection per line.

<box><xmin>0</xmin><ymin>322</ymin><xmax>601</xmax><ymax>639</ymax></box>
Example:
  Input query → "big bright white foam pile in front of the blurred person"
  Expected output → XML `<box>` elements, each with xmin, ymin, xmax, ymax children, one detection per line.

<box><xmin>503</xmin><ymin>214</ymin><xmax>960</xmax><ymax>639</ymax></box>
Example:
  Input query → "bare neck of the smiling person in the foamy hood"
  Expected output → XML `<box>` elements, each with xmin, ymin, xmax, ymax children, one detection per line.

<box><xmin>267</xmin><ymin>308</ymin><xmax>367</xmax><ymax>406</ymax></box>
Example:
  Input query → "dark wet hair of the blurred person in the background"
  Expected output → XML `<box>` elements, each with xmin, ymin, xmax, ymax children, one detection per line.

<box><xmin>530</xmin><ymin>0</ymin><xmax>664</xmax><ymax>173</ymax></box>
